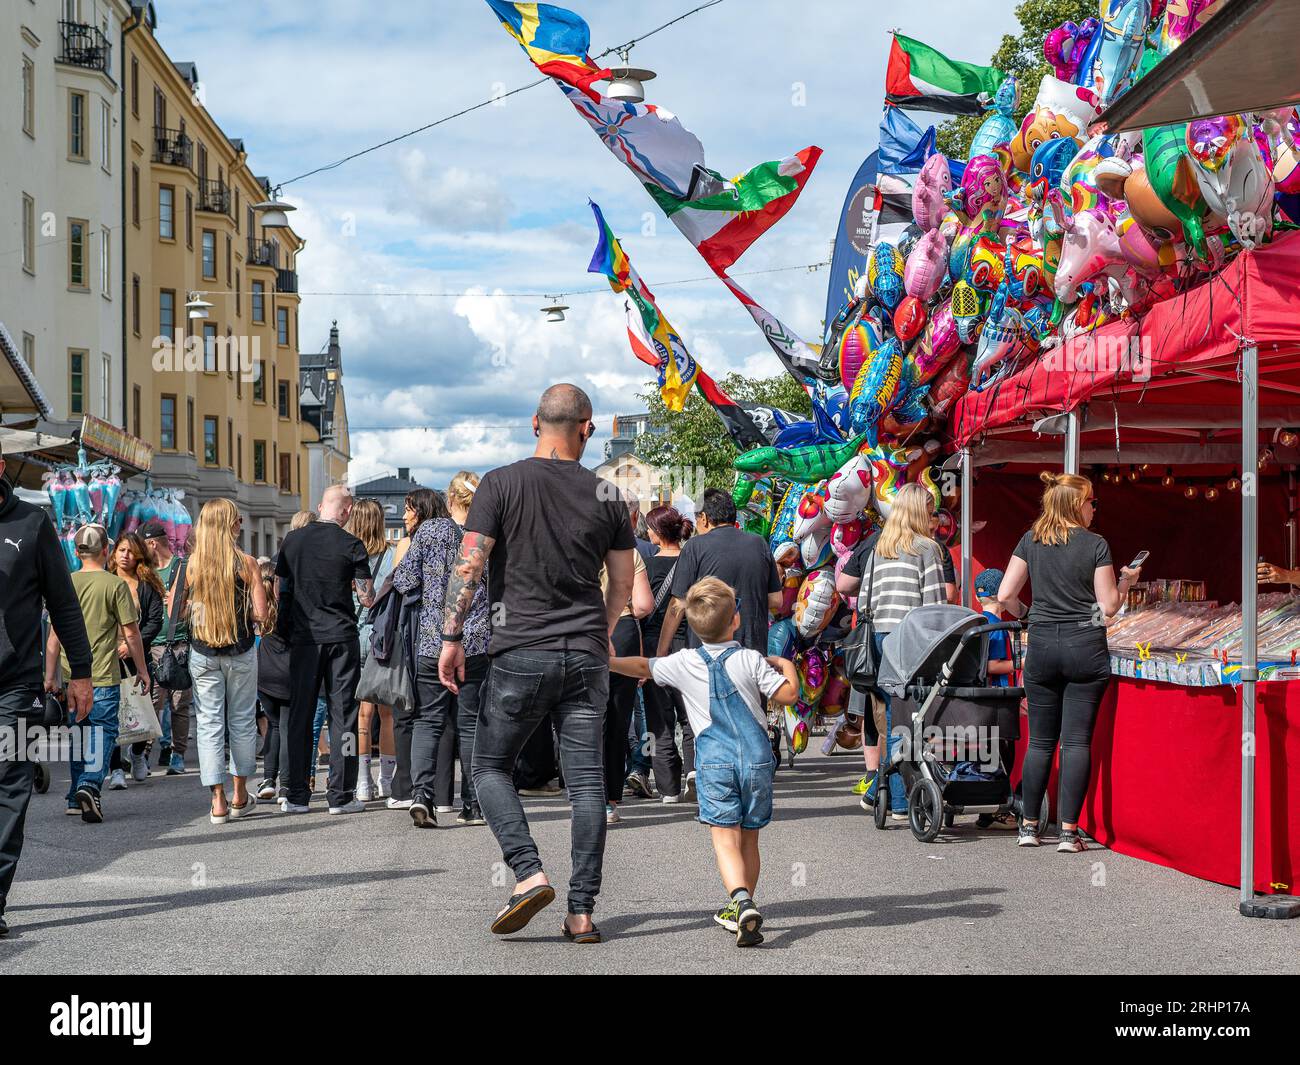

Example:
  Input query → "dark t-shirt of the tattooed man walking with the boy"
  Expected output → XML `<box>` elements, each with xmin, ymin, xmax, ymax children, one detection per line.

<box><xmin>465</xmin><ymin>458</ymin><xmax>636</xmax><ymax>658</ymax></box>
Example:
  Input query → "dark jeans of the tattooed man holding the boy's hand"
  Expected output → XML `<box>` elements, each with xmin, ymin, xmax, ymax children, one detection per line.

<box><xmin>473</xmin><ymin>649</ymin><xmax>611</xmax><ymax>913</ymax></box>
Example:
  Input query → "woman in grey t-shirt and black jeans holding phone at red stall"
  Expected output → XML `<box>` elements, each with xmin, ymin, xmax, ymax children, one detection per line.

<box><xmin>997</xmin><ymin>472</ymin><xmax>1141</xmax><ymax>852</ymax></box>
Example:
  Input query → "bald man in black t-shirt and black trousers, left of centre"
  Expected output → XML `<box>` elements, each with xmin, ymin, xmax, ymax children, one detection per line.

<box><xmin>276</xmin><ymin>485</ymin><xmax>374</xmax><ymax>814</ymax></box>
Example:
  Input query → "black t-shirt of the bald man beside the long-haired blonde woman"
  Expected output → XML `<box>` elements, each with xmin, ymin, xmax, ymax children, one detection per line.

<box><xmin>276</xmin><ymin>521</ymin><xmax>371</xmax><ymax>644</ymax></box>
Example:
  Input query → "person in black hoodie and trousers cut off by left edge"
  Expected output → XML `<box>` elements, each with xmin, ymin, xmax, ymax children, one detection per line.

<box><xmin>0</xmin><ymin>458</ymin><xmax>94</xmax><ymax>935</ymax></box>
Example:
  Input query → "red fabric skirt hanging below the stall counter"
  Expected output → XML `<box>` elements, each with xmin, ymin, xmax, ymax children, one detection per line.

<box><xmin>1018</xmin><ymin>677</ymin><xmax>1300</xmax><ymax>893</ymax></box>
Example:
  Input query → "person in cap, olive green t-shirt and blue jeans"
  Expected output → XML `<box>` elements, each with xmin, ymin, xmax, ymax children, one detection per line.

<box><xmin>46</xmin><ymin>524</ymin><xmax>150</xmax><ymax>824</ymax></box>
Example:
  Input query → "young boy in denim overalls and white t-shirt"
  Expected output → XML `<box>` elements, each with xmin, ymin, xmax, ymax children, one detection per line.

<box><xmin>610</xmin><ymin>577</ymin><xmax>800</xmax><ymax>947</ymax></box>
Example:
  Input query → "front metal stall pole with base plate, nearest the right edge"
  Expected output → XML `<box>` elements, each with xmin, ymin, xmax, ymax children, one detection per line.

<box><xmin>1238</xmin><ymin>345</ymin><xmax>1300</xmax><ymax>918</ymax></box>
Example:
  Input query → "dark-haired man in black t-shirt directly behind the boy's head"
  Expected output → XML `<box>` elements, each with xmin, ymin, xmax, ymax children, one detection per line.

<box><xmin>657</xmin><ymin>488</ymin><xmax>781</xmax><ymax>658</ymax></box>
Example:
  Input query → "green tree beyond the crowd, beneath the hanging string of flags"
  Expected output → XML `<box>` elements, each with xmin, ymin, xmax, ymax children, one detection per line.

<box><xmin>636</xmin><ymin>373</ymin><xmax>813</xmax><ymax>492</ymax></box>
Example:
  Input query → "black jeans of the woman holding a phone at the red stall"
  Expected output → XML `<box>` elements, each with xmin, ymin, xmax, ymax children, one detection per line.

<box><xmin>1021</xmin><ymin>623</ymin><xmax>1110</xmax><ymax>824</ymax></box>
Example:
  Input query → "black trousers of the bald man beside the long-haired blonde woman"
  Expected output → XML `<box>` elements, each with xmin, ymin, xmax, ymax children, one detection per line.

<box><xmin>286</xmin><ymin>638</ymin><xmax>361</xmax><ymax>806</ymax></box>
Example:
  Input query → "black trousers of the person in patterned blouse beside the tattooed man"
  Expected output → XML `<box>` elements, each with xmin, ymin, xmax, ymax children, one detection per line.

<box><xmin>411</xmin><ymin>654</ymin><xmax>488</xmax><ymax>809</ymax></box>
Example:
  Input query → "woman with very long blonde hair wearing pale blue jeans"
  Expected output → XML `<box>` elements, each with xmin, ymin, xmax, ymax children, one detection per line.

<box><xmin>173</xmin><ymin>499</ymin><xmax>268</xmax><ymax>824</ymax></box>
